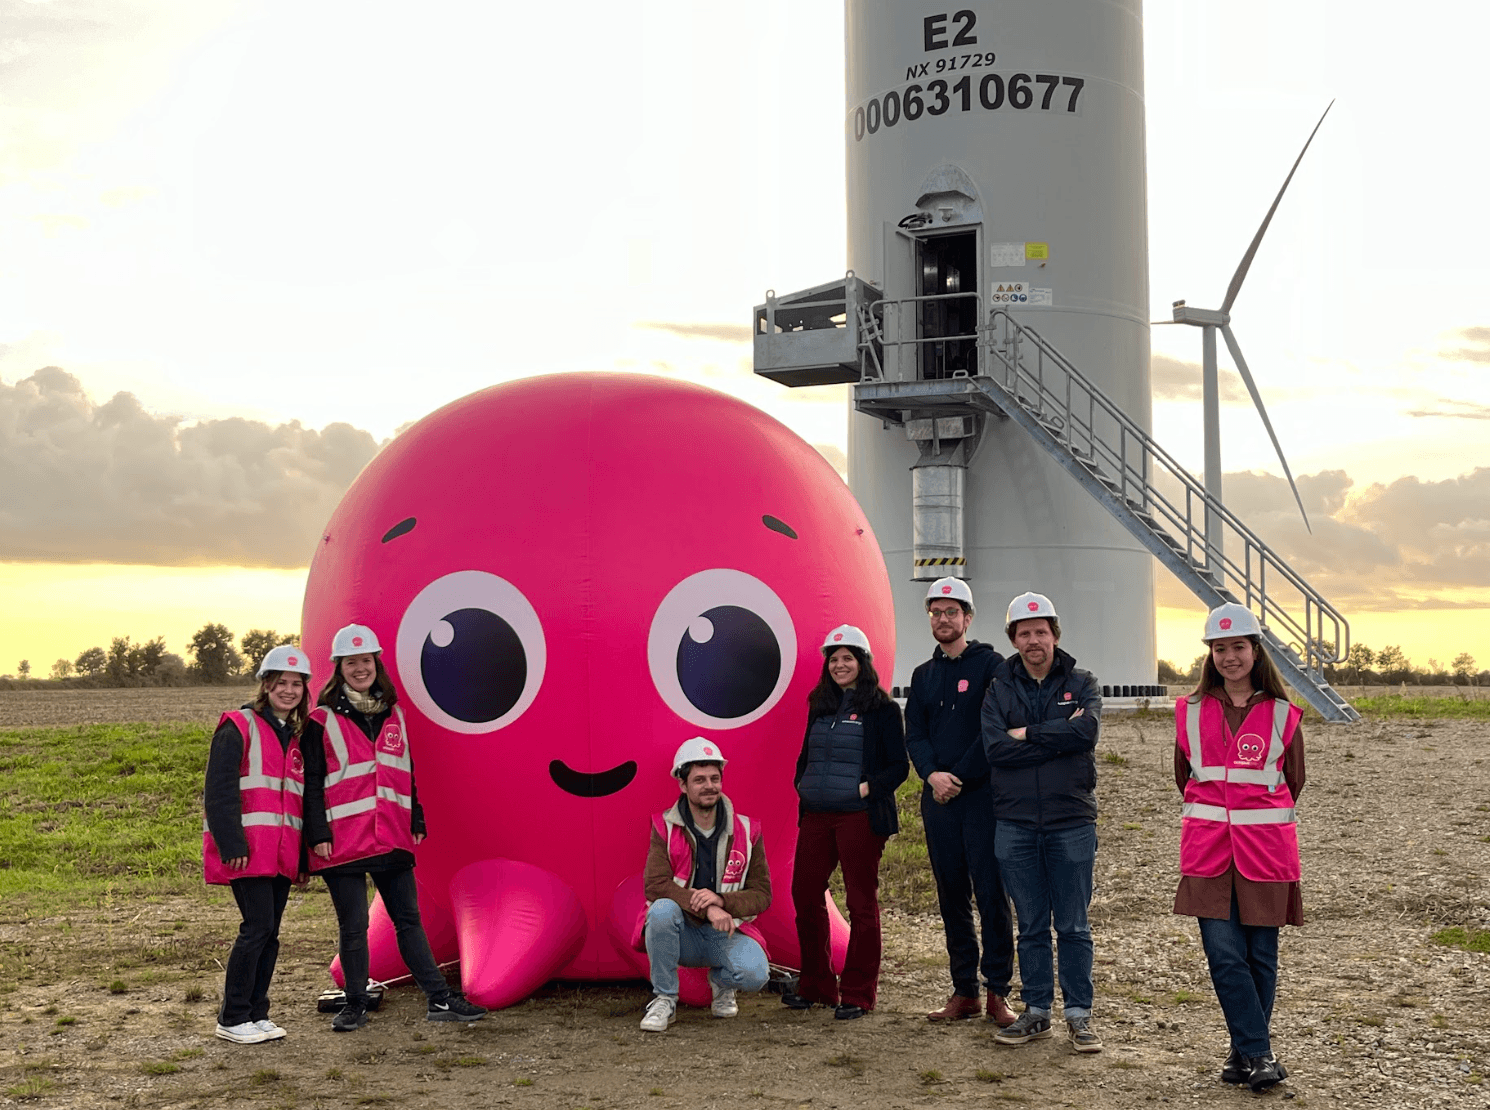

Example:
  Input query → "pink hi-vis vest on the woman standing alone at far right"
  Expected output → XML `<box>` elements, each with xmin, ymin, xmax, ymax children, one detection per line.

<box><xmin>1174</xmin><ymin>694</ymin><xmax>1304</xmax><ymax>882</ymax></box>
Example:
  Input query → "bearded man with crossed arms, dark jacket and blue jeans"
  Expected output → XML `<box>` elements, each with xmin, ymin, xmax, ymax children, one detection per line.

<box><xmin>983</xmin><ymin>593</ymin><xmax>1103</xmax><ymax>1052</ymax></box>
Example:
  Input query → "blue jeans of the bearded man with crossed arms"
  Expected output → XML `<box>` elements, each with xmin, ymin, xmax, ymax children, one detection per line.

<box><xmin>994</xmin><ymin>821</ymin><xmax>1097</xmax><ymax>1021</ymax></box>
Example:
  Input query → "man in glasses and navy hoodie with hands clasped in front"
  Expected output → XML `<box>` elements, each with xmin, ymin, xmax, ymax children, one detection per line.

<box><xmin>906</xmin><ymin>578</ymin><xmax>1015</xmax><ymax>1025</ymax></box>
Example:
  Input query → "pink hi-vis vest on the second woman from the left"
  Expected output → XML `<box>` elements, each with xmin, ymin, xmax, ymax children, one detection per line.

<box><xmin>310</xmin><ymin>705</ymin><xmax>414</xmax><ymax>872</ymax></box>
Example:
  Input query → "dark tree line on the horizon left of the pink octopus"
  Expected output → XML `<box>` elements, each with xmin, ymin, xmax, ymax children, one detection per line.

<box><xmin>6</xmin><ymin>623</ymin><xmax>299</xmax><ymax>687</ymax></box>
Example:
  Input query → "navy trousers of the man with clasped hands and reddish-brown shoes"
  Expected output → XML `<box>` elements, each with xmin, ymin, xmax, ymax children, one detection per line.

<box><xmin>921</xmin><ymin>785</ymin><xmax>1015</xmax><ymax>998</ymax></box>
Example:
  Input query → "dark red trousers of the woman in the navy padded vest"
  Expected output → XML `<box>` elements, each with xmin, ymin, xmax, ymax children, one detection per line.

<box><xmin>791</xmin><ymin>812</ymin><xmax>890</xmax><ymax>1010</ymax></box>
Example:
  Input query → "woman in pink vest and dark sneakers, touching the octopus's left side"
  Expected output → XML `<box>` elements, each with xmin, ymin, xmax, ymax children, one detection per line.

<box><xmin>305</xmin><ymin>624</ymin><xmax>486</xmax><ymax>1033</ymax></box>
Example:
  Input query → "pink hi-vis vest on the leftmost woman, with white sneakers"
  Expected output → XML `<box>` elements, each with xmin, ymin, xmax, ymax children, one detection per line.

<box><xmin>201</xmin><ymin>709</ymin><xmax>305</xmax><ymax>885</ymax></box>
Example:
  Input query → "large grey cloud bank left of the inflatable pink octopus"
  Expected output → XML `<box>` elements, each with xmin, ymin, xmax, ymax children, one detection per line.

<box><xmin>0</xmin><ymin>367</ymin><xmax>378</xmax><ymax>568</ymax></box>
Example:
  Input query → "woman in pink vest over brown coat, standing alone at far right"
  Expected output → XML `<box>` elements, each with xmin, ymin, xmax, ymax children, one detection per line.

<box><xmin>1174</xmin><ymin>603</ymin><xmax>1304</xmax><ymax>1091</ymax></box>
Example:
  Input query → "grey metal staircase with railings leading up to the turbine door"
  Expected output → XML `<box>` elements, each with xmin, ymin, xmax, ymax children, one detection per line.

<box><xmin>854</xmin><ymin>306</ymin><xmax>1360</xmax><ymax>723</ymax></box>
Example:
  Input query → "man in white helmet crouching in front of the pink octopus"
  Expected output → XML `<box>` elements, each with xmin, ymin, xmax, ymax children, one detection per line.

<box><xmin>642</xmin><ymin>736</ymin><xmax>770</xmax><ymax>1033</ymax></box>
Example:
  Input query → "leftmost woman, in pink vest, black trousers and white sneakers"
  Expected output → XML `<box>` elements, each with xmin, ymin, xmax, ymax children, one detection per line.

<box><xmin>201</xmin><ymin>645</ymin><xmax>310</xmax><ymax>1044</ymax></box>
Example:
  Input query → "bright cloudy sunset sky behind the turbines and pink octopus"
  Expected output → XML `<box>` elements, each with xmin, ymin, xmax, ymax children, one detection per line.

<box><xmin>0</xmin><ymin>0</ymin><xmax>1490</xmax><ymax>673</ymax></box>
